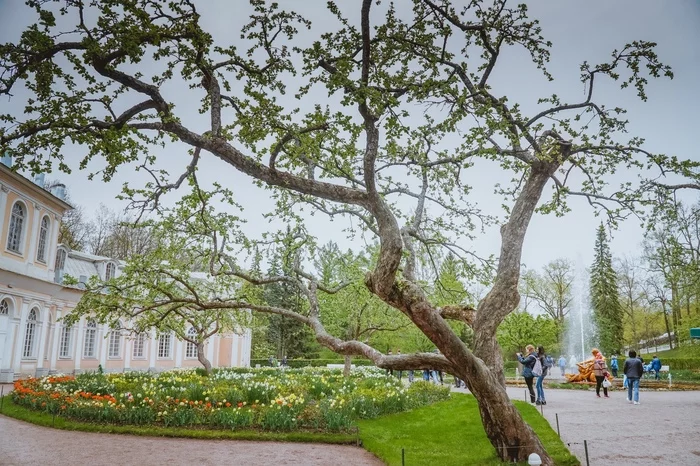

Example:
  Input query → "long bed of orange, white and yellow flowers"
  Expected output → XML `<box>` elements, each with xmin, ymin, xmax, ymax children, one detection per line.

<box><xmin>12</xmin><ymin>368</ymin><xmax>449</xmax><ymax>432</ymax></box>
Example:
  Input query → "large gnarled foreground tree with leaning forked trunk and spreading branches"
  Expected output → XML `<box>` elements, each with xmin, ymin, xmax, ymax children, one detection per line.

<box><xmin>0</xmin><ymin>0</ymin><xmax>697</xmax><ymax>458</ymax></box>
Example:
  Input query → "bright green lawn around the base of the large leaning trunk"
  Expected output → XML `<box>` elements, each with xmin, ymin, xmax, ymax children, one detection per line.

<box><xmin>358</xmin><ymin>393</ymin><xmax>580</xmax><ymax>466</ymax></box>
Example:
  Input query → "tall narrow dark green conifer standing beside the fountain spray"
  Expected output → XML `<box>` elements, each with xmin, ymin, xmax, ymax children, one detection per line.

<box><xmin>590</xmin><ymin>224</ymin><xmax>623</xmax><ymax>354</ymax></box>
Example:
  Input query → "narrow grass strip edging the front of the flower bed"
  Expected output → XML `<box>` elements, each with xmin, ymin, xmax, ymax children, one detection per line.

<box><xmin>0</xmin><ymin>395</ymin><xmax>357</xmax><ymax>444</ymax></box>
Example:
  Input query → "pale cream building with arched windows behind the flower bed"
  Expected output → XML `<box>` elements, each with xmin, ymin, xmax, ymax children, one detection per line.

<box><xmin>0</xmin><ymin>162</ymin><xmax>251</xmax><ymax>382</ymax></box>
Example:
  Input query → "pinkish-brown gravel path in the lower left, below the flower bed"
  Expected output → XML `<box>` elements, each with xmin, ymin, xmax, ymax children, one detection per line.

<box><xmin>0</xmin><ymin>416</ymin><xmax>382</xmax><ymax>466</ymax></box>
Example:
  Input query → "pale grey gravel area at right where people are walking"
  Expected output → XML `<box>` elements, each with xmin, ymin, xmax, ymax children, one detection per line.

<box><xmin>500</xmin><ymin>388</ymin><xmax>700</xmax><ymax>466</ymax></box>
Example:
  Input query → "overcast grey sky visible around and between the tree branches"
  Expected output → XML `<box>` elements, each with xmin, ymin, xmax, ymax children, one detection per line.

<box><xmin>0</xmin><ymin>0</ymin><xmax>700</xmax><ymax>267</ymax></box>
